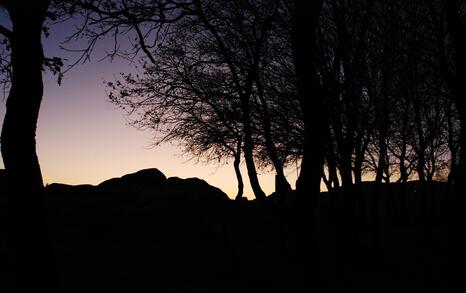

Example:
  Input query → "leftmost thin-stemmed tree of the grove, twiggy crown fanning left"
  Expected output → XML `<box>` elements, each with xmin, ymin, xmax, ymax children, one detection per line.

<box><xmin>107</xmin><ymin>56</ymin><xmax>243</xmax><ymax>196</ymax></box>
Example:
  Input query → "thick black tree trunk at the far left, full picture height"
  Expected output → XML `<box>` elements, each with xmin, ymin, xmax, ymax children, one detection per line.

<box><xmin>0</xmin><ymin>0</ymin><xmax>54</xmax><ymax>292</ymax></box>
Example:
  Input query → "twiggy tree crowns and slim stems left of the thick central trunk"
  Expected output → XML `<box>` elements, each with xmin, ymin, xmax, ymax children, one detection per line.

<box><xmin>70</xmin><ymin>1</ymin><xmax>296</xmax><ymax>198</ymax></box>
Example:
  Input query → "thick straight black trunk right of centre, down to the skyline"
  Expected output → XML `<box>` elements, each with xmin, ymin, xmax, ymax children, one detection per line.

<box><xmin>292</xmin><ymin>0</ymin><xmax>328</xmax><ymax>197</ymax></box>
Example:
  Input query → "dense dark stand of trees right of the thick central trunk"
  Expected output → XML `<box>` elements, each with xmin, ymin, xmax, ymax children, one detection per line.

<box><xmin>319</xmin><ymin>1</ymin><xmax>460</xmax><ymax>188</ymax></box>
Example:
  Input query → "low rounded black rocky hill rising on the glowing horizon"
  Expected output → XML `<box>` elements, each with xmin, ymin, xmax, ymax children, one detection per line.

<box><xmin>46</xmin><ymin>168</ymin><xmax>228</xmax><ymax>208</ymax></box>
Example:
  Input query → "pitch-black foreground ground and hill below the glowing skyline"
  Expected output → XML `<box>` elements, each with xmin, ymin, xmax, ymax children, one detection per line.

<box><xmin>0</xmin><ymin>171</ymin><xmax>464</xmax><ymax>293</ymax></box>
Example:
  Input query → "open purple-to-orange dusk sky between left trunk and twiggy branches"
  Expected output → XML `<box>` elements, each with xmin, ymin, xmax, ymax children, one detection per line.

<box><xmin>0</xmin><ymin>15</ymin><xmax>296</xmax><ymax>198</ymax></box>
